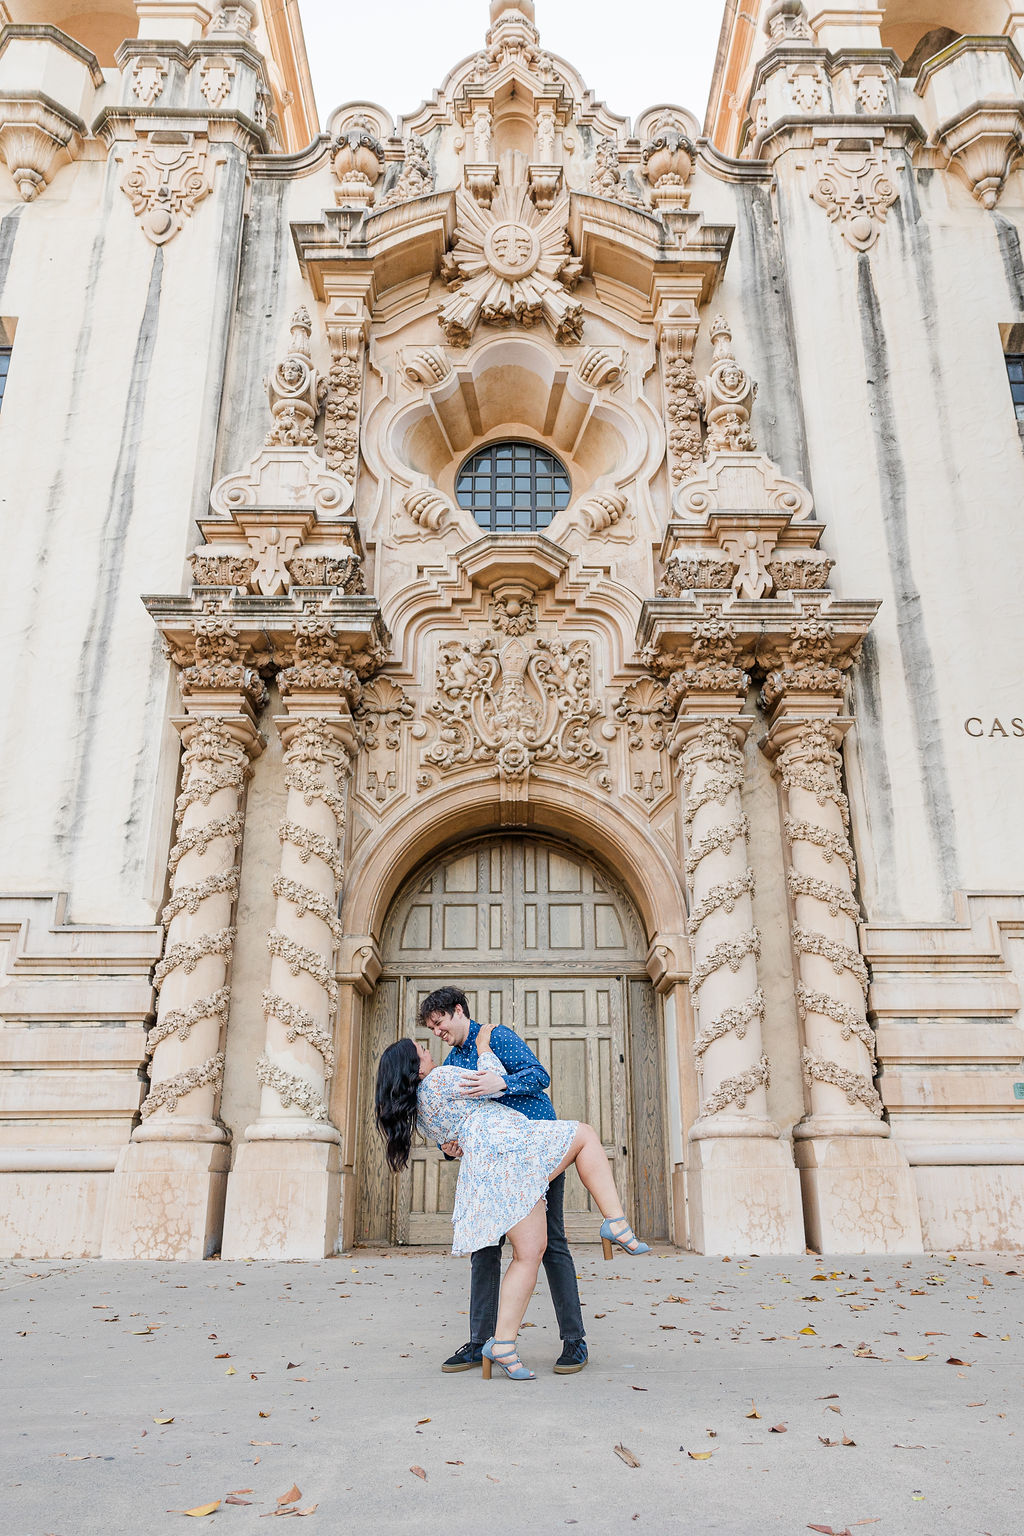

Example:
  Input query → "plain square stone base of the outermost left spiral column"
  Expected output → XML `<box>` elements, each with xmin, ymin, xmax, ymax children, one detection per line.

<box><xmin>103</xmin><ymin>1141</ymin><xmax>230</xmax><ymax>1260</ymax></box>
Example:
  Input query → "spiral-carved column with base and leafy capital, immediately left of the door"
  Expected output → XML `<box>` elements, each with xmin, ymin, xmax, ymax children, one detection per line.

<box><xmin>223</xmin><ymin>619</ymin><xmax>361</xmax><ymax>1258</ymax></box>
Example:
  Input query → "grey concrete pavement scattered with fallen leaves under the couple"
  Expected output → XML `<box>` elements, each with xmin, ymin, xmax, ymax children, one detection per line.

<box><xmin>0</xmin><ymin>1249</ymin><xmax>1024</xmax><ymax>1536</ymax></box>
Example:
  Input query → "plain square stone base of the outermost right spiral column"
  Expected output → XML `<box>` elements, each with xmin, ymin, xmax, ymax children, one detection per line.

<box><xmin>794</xmin><ymin>1137</ymin><xmax>924</xmax><ymax>1253</ymax></box>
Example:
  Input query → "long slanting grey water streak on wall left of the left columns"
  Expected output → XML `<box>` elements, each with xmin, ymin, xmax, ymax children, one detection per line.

<box><xmin>57</xmin><ymin>246</ymin><xmax>164</xmax><ymax>860</ymax></box>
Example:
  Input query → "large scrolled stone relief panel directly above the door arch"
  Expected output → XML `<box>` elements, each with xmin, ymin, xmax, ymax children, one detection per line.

<box><xmin>424</xmin><ymin>634</ymin><xmax>603</xmax><ymax>782</ymax></box>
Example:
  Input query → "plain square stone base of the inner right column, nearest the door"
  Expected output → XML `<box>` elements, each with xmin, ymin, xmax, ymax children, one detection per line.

<box><xmin>686</xmin><ymin>1137</ymin><xmax>804</xmax><ymax>1253</ymax></box>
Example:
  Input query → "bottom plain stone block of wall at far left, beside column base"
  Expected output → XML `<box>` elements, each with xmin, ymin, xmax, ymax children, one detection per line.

<box><xmin>0</xmin><ymin>1170</ymin><xmax>111</xmax><ymax>1258</ymax></box>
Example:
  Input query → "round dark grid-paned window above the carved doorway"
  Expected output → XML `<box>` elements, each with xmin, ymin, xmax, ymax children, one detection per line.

<box><xmin>454</xmin><ymin>442</ymin><xmax>573</xmax><ymax>533</ymax></box>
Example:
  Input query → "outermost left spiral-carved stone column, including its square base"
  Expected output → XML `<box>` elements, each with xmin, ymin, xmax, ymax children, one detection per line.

<box><xmin>104</xmin><ymin>708</ymin><xmax>263</xmax><ymax>1258</ymax></box>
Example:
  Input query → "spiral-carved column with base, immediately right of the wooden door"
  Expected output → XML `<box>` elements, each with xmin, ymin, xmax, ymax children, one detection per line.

<box><xmin>674</xmin><ymin>712</ymin><xmax>803</xmax><ymax>1253</ymax></box>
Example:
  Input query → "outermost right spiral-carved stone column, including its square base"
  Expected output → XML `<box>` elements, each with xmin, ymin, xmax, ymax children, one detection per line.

<box><xmin>766</xmin><ymin>714</ymin><xmax>921</xmax><ymax>1253</ymax></box>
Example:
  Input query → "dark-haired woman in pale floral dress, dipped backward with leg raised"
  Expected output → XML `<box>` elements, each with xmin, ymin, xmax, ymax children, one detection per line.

<box><xmin>376</xmin><ymin>1026</ymin><xmax>649</xmax><ymax>1381</ymax></box>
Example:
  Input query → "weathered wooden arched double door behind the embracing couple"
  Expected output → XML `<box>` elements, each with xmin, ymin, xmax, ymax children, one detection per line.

<box><xmin>356</xmin><ymin>836</ymin><xmax>668</xmax><ymax>1244</ymax></box>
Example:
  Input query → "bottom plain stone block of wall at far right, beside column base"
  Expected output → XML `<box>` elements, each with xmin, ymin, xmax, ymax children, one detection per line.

<box><xmin>913</xmin><ymin>1166</ymin><xmax>1024</xmax><ymax>1250</ymax></box>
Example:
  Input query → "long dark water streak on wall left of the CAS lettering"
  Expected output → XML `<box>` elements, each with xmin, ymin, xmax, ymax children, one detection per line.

<box><xmin>857</xmin><ymin>252</ymin><xmax>958</xmax><ymax>892</ymax></box>
